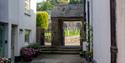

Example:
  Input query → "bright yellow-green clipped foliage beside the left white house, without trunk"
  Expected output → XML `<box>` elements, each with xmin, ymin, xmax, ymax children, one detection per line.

<box><xmin>36</xmin><ymin>12</ymin><xmax>48</xmax><ymax>30</ymax></box>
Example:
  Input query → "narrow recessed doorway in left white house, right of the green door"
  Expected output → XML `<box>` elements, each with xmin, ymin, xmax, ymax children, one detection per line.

<box><xmin>11</xmin><ymin>25</ymin><xmax>17</xmax><ymax>62</ymax></box>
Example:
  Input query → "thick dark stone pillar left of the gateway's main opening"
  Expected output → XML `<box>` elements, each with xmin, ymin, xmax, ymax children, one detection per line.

<box><xmin>52</xmin><ymin>18</ymin><xmax>64</xmax><ymax>47</ymax></box>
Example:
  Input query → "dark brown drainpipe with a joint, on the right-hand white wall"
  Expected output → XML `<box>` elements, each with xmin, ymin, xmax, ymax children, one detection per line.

<box><xmin>110</xmin><ymin>0</ymin><xmax>118</xmax><ymax>63</ymax></box>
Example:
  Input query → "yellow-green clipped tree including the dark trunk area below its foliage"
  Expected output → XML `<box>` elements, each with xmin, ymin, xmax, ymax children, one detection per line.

<box><xmin>36</xmin><ymin>11</ymin><xmax>48</xmax><ymax>45</ymax></box>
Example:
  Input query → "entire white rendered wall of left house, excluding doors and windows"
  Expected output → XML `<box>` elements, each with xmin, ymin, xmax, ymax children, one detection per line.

<box><xmin>0</xmin><ymin>0</ymin><xmax>36</xmax><ymax>58</ymax></box>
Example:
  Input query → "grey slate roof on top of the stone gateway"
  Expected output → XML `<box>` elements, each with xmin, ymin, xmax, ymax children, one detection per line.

<box><xmin>51</xmin><ymin>4</ymin><xmax>84</xmax><ymax>17</ymax></box>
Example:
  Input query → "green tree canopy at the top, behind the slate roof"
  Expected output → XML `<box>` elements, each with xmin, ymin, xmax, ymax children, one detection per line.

<box><xmin>37</xmin><ymin>0</ymin><xmax>83</xmax><ymax>11</ymax></box>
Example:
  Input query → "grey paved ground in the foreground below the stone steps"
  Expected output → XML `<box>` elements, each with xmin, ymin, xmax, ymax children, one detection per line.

<box><xmin>18</xmin><ymin>54</ymin><xmax>83</xmax><ymax>63</ymax></box>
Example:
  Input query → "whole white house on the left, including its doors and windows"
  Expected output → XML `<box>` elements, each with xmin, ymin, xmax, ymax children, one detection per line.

<box><xmin>0</xmin><ymin>0</ymin><xmax>36</xmax><ymax>61</ymax></box>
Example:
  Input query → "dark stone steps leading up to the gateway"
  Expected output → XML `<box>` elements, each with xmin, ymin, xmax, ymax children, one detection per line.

<box><xmin>41</xmin><ymin>46</ymin><xmax>80</xmax><ymax>54</ymax></box>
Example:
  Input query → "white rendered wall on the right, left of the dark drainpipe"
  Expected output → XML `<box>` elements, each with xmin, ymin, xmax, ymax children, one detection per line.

<box><xmin>92</xmin><ymin>0</ymin><xmax>111</xmax><ymax>63</ymax></box>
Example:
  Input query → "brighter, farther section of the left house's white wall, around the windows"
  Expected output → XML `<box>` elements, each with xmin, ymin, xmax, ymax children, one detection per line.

<box><xmin>16</xmin><ymin>0</ymin><xmax>36</xmax><ymax>56</ymax></box>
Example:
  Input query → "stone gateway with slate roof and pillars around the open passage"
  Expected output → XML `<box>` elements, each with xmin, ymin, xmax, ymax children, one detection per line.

<box><xmin>51</xmin><ymin>4</ymin><xmax>85</xmax><ymax>47</ymax></box>
